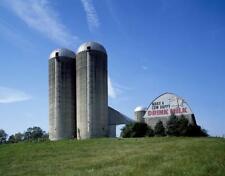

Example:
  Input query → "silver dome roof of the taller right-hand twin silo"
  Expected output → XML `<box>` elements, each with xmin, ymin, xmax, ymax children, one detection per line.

<box><xmin>77</xmin><ymin>42</ymin><xmax>106</xmax><ymax>54</ymax></box>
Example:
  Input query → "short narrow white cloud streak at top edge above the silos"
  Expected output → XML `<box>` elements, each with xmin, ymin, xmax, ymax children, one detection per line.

<box><xmin>81</xmin><ymin>0</ymin><xmax>100</xmax><ymax>31</ymax></box>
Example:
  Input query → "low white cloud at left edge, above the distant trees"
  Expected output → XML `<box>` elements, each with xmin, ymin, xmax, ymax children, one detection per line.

<box><xmin>0</xmin><ymin>86</ymin><xmax>31</xmax><ymax>103</ymax></box>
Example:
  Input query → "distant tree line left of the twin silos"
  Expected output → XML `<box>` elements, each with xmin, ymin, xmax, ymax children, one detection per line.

<box><xmin>0</xmin><ymin>126</ymin><xmax>48</xmax><ymax>144</ymax></box>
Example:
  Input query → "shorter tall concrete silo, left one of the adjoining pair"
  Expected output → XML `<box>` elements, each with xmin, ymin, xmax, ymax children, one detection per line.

<box><xmin>49</xmin><ymin>49</ymin><xmax>76</xmax><ymax>140</ymax></box>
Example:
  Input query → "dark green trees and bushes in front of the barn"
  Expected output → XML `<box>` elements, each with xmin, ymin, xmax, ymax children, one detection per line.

<box><xmin>121</xmin><ymin>115</ymin><xmax>208</xmax><ymax>138</ymax></box>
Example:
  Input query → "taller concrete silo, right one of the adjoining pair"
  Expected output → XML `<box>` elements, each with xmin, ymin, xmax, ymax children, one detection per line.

<box><xmin>76</xmin><ymin>42</ymin><xmax>108</xmax><ymax>139</ymax></box>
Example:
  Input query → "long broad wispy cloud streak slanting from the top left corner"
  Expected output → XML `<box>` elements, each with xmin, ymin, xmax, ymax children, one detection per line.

<box><xmin>3</xmin><ymin>0</ymin><xmax>78</xmax><ymax>47</ymax></box>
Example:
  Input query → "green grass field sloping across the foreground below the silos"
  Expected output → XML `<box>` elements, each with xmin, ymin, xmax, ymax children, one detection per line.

<box><xmin>0</xmin><ymin>137</ymin><xmax>225</xmax><ymax>176</ymax></box>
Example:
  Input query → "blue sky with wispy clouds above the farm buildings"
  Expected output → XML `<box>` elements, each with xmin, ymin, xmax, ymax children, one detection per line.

<box><xmin>0</xmin><ymin>0</ymin><xmax>225</xmax><ymax>136</ymax></box>
